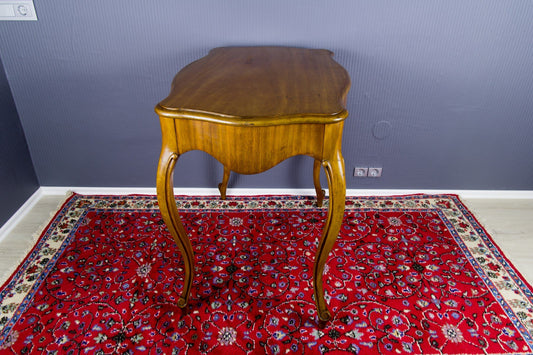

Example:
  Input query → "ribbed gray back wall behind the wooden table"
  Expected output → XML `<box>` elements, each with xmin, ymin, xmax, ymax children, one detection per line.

<box><xmin>0</xmin><ymin>0</ymin><xmax>533</xmax><ymax>190</ymax></box>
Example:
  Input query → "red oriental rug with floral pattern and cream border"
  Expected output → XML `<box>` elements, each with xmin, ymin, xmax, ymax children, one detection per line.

<box><xmin>0</xmin><ymin>195</ymin><xmax>533</xmax><ymax>354</ymax></box>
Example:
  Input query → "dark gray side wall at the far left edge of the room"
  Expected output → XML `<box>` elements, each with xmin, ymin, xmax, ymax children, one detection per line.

<box><xmin>0</xmin><ymin>60</ymin><xmax>39</xmax><ymax>226</ymax></box>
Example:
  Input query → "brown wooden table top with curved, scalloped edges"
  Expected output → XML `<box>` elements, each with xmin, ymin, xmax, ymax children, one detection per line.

<box><xmin>156</xmin><ymin>47</ymin><xmax>350</xmax><ymax>126</ymax></box>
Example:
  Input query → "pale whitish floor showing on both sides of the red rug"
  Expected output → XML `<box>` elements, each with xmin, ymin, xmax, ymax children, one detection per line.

<box><xmin>0</xmin><ymin>194</ymin><xmax>533</xmax><ymax>284</ymax></box>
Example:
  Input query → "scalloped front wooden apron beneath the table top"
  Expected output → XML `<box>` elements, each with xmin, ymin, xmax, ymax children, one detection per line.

<box><xmin>161</xmin><ymin>117</ymin><xmax>343</xmax><ymax>174</ymax></box>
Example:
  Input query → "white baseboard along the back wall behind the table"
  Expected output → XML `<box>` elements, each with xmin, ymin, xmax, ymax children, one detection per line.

<box><xmin>40</xmin><ymin>186</ymin><xmax>533</xmax><ymax>199</ymax></box>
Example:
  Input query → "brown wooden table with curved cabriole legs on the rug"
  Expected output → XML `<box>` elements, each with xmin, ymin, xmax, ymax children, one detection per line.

<box><xmin>155</xmin><ymin>47</ymin><xmax>350</xmax><ymax>321</ymax></box>
